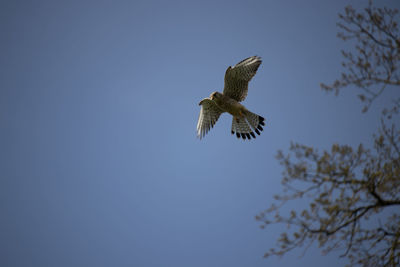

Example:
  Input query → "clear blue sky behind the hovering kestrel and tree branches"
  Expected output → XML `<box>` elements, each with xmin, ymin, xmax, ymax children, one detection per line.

<box><xmin>0</xmin><ymin>0</ymin><xmax>395</xmax><ymax>267</ymax></box>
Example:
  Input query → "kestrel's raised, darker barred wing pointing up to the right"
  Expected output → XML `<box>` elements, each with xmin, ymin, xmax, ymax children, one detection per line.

<box><xmin>223</xmin><ymin>56</ymin><xmax>262</xmax><ymax>102</ymax></box>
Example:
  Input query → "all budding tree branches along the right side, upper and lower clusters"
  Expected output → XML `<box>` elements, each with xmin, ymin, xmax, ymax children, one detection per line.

<box><xmin>256</xmin><ymin>2</ymin><xmax>400</xmax><ymax>266</ymax></box>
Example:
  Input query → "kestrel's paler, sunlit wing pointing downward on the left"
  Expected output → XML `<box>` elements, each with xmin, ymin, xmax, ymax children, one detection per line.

<box><xmin>197</xmin><ymin>98</ymin><xmax>223</xmax><ymax>139</ymax></box>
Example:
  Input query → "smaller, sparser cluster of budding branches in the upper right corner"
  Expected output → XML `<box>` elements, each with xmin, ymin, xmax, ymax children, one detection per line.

<box><xmin>321</xmin><ymin>1</ymin><xmax>400</xmax><ymax>112</ymax></box>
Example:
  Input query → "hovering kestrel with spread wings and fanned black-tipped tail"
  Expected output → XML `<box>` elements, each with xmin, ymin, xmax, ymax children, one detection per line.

<box><xmin>197</xmin><ymin>56</ymin><xmax>265</xmax><ymax>140</ymax></box>
